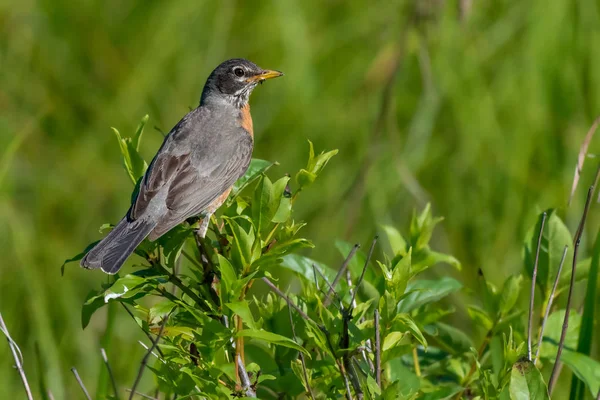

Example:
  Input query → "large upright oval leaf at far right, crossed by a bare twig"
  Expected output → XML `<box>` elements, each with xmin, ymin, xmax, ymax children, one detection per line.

<box><xmin>524</xmin><ymin>209</ymin><xmax>573</xmax><ymax>294</ymax></box>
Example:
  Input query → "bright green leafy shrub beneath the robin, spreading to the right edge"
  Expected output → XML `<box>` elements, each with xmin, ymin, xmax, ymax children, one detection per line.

<box><xmin>62</xmin><ymin>117</ymin><xmax>600</xmax><ymax>399</ymax></box>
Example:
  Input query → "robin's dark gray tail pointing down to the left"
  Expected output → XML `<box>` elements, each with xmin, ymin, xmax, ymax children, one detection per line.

<box><xmin>81</xmin><ymin>217</ymin><xmax>156</xmax><ymax>274</ymax></box>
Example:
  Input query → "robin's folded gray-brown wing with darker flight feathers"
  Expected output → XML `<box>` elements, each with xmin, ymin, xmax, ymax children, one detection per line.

<box><xmin>130</xmin><ymin>109</ymin><xmax>253</xmax><ymax>237</ymax></box>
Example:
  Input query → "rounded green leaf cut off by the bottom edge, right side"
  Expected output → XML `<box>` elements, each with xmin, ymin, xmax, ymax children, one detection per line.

<box><xmin>509</xmin><ymin>360</ymin><xmax>550</xmax><ymax>400</ymax></box>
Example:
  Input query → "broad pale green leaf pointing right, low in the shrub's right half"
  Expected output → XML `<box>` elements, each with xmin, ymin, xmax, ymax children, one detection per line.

<box><xmin>397</xmin><ymin>277</ymin><xmax>462</xmax><ymax>313</ymax></box>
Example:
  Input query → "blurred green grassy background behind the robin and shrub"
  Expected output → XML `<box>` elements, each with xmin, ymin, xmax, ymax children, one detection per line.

<box><xmin>0</xmin><ymin>0</ymin><xmax>600</xmax><ymax>399</ymax></box>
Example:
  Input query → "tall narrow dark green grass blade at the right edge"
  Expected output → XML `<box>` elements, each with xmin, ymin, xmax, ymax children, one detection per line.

<box><xmin>571</xmin><ymin>227</ymin><xmax>600</xmax><ymax>399</ymax></box>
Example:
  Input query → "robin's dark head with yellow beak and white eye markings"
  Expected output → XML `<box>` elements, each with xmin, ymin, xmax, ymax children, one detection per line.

<box><xmin>200</xmin><ymin>58</ymin><xmax>283</xmax><ymax>108</ymax></box>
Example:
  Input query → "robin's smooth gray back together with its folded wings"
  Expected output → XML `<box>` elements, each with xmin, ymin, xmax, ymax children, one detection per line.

<box><xmin>128</xmin><ymin>104</ymin><xmax>253</xmax><ymax>240</ymax></box>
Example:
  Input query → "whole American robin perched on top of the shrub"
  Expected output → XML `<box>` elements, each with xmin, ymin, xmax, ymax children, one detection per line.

<box><xmin>81</xmin><ymin>58</ymin><xmax>283</xmax><ymax>274</ymax></box>
